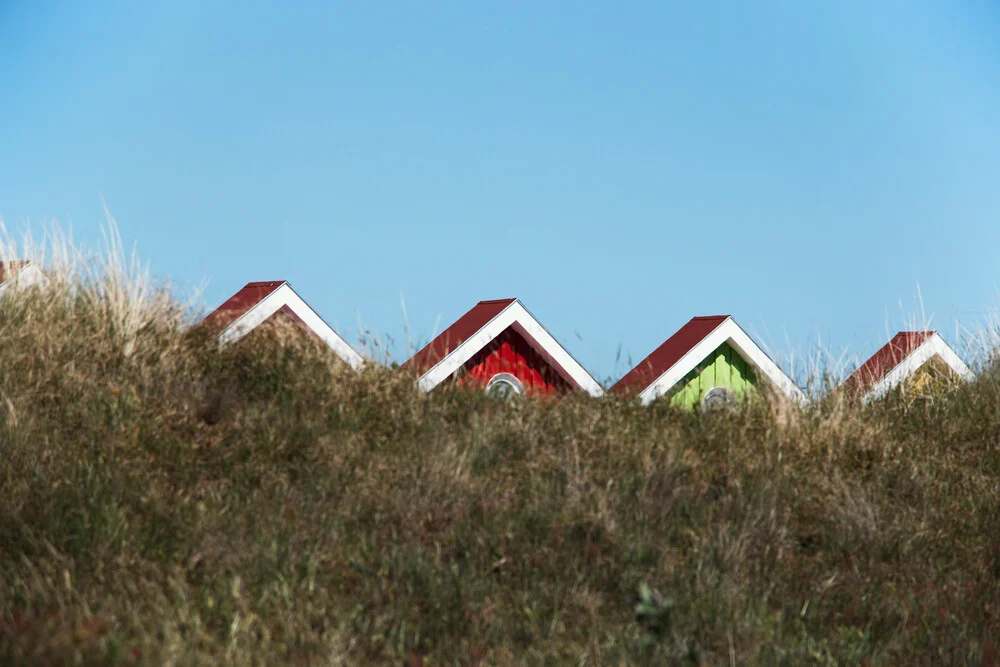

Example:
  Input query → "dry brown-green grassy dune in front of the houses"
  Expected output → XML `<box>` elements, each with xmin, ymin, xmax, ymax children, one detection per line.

<box><xmin>0</xmin><ymin>253</ymin><xmax>1000</xmax><ymax>665</ymax></box>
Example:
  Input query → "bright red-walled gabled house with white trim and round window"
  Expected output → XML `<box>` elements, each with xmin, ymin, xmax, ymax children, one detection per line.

<box><xmin>403</xmin><ymin>299</ymin><xmax>604</xmax><ymax>396</ymax></box>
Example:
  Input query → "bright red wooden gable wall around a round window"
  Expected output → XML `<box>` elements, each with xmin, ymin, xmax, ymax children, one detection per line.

<box><xmin>458</xmin><ymin>328</ymin><xmax>572</xmax><ymax>395</ymax></box>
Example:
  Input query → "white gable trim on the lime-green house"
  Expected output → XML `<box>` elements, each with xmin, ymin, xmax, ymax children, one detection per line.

<box><xmin>639</xmin><ymin>317</ymin><xmax>806</xmax><ymax>405</ymax></box>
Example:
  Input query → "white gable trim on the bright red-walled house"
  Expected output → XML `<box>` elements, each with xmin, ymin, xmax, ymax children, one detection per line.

<box><xmin>417</xmin><ymin>299</ymin><xmax>604</xmax><ymax>396</ymax></box>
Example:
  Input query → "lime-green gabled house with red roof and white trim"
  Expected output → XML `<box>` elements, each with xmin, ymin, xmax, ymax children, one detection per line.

<box><xmin>611</xmin><ymin>315</ymin><xmax>805</xmax><ymax>409</ymax></box>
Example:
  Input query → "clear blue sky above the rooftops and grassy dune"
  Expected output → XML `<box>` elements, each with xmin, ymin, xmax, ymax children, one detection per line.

<box><xmin>0</xmin><ymin>0</ymin><xmax>1000</xmax><ymax>378</ymax></box>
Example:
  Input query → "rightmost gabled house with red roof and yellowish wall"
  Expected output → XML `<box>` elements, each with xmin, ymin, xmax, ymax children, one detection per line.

<box><xmin>842</xmin><ymin>331</ymin><xmax>972</xmax><ymax>403</ymax></box>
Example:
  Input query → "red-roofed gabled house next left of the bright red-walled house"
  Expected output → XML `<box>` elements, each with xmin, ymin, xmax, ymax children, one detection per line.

<box><xmin>199</xmin><ymin>280</ymin><xmax>364</xmax><ymax>369</ymax></box>
